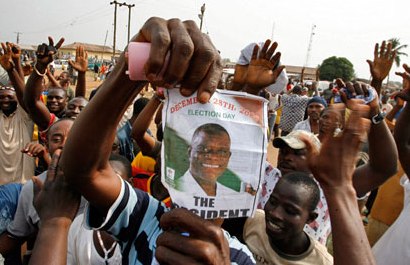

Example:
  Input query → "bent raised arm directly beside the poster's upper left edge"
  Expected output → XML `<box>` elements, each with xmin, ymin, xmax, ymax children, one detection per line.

<box><xmin>131</xmin><ymin>91</ymin><xmax>161</xmax><ymax>155</ymax></box>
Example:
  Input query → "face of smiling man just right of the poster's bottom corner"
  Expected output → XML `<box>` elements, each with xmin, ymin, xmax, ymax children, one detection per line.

<box><xmin>265</xmin><ymin>180</ymin><xmax>315</xmax><ymax>241</ymax></box>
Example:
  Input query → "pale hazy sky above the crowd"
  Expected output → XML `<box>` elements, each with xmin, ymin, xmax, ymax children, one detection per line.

<box><xmin>0</xmin><ymin>0</ymin><xmax>410</xmax><ymax>81</ymax></box>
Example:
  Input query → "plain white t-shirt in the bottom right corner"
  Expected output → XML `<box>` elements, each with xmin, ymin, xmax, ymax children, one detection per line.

<box><xmin>372</xmin><ymin>175</ymin><xmax>410</xmax><ymax>265</ymax></box>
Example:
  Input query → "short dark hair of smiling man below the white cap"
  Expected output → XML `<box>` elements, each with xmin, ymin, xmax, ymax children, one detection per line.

<box><xmin>281</xmin><ymin>171</ymin><xmax>320</xmax><ymax>211</ymax></box>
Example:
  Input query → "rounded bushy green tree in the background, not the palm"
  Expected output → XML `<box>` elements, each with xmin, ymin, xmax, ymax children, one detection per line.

<box><xmin>319</xmin><ymin>56</ymin><xmax>354</xmax><ymax>81</ymax></box>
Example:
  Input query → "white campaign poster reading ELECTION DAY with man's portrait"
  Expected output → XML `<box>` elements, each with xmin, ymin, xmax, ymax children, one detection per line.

<box><xmin>161</xmin><ymin>89</ymin><xmax>268</xmax><ymax>219</ymax></box>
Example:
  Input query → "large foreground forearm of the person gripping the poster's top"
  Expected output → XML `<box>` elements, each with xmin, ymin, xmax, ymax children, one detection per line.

<box><xmin>61</xmin><ymin>52</ymin><xmax>146</xmax><ymax>186</ymax></box>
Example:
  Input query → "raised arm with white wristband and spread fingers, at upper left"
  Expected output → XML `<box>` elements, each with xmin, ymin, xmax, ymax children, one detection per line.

<box><xmin>24</xmin><ymin>37</ymin><xmax>64</xmax><ymax>131</ymax></box>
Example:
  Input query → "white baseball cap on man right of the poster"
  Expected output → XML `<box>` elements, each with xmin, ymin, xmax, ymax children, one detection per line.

<box><xmin>273</xmin><ymin>130</ymin><xmax>320</xmax><ymax>149</ymax></box>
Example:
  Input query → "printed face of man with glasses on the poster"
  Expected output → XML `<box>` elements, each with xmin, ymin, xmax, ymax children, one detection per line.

<box><xmin>188</xmin><ymin>132</ymin><xmax>231</xmax><ymax>182</ymax></box>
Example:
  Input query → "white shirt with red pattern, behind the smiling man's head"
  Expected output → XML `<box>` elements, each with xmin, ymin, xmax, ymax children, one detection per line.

<box><xmin>258</xmin><ymin>162</ymin><xmax>332</xmax><ymax>244</ymax></box>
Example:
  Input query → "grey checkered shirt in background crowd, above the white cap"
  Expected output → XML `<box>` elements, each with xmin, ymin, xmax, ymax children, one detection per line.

<box><xmin>279</xmin><ymin>94</ymin><xmax>310</xmax><ymax>132</ymax></box>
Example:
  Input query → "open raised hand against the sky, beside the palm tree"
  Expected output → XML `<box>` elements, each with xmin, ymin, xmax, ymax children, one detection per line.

<box><xmin>367</xmin><ymin>41</ymin><xmax>396</xmax><ymax>82</ymax></box>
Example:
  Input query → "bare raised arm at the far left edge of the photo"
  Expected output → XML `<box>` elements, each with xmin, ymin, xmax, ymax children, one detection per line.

<box><xmin>0</xmin><ymin>42</ymin><xmax>27</xmax><ymax>111</ymax></box>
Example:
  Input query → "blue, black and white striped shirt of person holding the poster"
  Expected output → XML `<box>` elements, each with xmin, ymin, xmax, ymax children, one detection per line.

<box><xmin>85</xmin><ymin>178</ymin><xmax>255</xmax><ymax>264</ymax></box>
